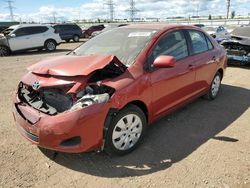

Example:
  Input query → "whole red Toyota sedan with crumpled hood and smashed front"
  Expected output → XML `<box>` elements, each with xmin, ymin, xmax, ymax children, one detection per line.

<box><xmin>14</xmin><ymin>24</ymin><xmax>226</xmax><ymax>155</ymax></box>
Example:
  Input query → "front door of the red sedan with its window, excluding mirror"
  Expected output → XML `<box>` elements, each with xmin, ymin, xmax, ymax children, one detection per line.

<box><xmin>149</xmin><ymin>30</ymin><xmax>195</xmax><ymax>117</ymax></box>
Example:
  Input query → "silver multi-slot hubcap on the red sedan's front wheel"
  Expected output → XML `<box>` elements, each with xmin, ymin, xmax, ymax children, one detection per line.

<box><xmin>112</xmin><ymin>114</ymin><xmax>142</xmax><ymax>150</ymax></box>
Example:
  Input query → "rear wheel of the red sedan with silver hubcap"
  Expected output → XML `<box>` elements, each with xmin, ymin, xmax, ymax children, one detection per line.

<box><xmin>204</xmin><ymin>72</ymin><xmax>222</xmax><ymax>100</ymax></box>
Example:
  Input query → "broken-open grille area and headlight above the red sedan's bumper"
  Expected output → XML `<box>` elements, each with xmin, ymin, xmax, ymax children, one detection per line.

<box><xmin>18</xmin><ymin>83</ymin><xmax>114</xmax><ymax>115</ymax></box>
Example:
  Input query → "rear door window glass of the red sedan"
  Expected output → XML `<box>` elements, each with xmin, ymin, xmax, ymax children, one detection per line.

<box><xmin>188</xmin><ymin>30</ymin><xmax>209</xmax><ymax>54</ymax></box>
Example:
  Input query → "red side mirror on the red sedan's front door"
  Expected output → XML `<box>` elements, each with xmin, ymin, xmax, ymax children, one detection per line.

<box><xmin>153</xmin><ymin>55</ymin><xmax>176</xmax><ymax>68</ymax></box>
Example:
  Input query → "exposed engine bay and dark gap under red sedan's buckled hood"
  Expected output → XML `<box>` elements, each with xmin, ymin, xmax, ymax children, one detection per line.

<box><xmin>18</xmin><ymin>55</ymin><xmax>126</xmax><ymax>115</ymax></box>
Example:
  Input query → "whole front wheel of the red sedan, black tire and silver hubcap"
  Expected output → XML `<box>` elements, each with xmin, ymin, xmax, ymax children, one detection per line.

<box><xmin>104</xmin><ymin>105</ymin><xmax>147</xmax><ymax>155</ymax></box>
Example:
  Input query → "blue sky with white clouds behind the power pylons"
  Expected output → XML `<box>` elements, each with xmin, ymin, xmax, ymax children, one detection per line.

<box><xmin>0</xmin><ymin>0</ymin><xmax>250</xmax><ymax>22</ymax></box>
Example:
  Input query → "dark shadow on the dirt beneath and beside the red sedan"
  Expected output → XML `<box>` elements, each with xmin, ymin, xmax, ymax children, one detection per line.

<box><xmin>41</xmin><ymin>85</ymin><xmax>250</xmax><ymax>178</ymax></box>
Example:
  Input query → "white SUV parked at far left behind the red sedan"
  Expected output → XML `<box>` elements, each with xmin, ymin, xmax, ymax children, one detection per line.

<box><xmin>0</xmin><ymin>24</ymin><xmax>62</xmax><ymax>56</ymax></box>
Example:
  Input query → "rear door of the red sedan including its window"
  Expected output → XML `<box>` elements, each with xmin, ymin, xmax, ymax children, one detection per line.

<box><xmin>187</xmin><ymin>30</ymin><xmax>219</xmax><ymax>93</ymax></box>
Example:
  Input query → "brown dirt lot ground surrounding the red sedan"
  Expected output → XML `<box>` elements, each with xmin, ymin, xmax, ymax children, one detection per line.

<box><xmin>0</xmin><ymin>43</ymin><xmax>250</xmax><ymax>188</ymax></box>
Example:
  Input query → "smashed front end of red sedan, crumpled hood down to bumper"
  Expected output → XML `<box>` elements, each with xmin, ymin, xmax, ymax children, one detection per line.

<box><xmin>13</xmin><ymin>56</ymin><xmax>126</xmax><ymax>153</ymax></box>
